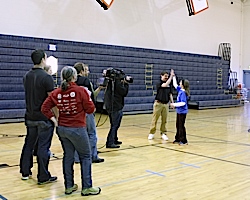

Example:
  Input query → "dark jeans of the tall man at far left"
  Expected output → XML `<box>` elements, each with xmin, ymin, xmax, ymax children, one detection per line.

<box><xmin>20</xmin><ymin>120</ymin><xmax>54</xmax><ymax>182</ymax></box>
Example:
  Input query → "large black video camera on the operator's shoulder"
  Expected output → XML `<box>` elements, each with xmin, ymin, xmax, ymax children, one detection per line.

<box><xmin>100</xmin><ymin>68</ymin><xmax>134</xmax><ymax>87</ymax></box>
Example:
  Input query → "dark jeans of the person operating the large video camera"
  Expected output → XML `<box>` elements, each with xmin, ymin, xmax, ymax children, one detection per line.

<box><xmin>106</xmin><ymin>110</ymin><xmax>123</xmax><ymax>146</ymax></box>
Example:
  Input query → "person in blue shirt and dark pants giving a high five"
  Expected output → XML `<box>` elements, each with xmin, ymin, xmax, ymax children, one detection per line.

<box><xmin>170</xmin><ymin>76</ymin><xmax>190</xmax><ymax>145</ymax></box>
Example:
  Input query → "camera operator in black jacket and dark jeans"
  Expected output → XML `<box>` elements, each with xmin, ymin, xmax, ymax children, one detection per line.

<box><xmin>104</xmin><ymin>71</ymin><xmax>129</xmax><ymax>148</ymax></box>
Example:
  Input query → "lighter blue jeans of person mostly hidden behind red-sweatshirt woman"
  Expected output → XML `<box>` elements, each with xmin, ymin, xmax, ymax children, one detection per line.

<box><xmin>75</xmin><ymin>113</ymin><xmax>98</xmax><ymax>162</ymax></box>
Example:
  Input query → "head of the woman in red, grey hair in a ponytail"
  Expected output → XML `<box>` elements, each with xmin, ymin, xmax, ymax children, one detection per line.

<box><xmin>61</xmin><ymin>66</ymin><xmax>77</xmax><ymax>91</ymax></box>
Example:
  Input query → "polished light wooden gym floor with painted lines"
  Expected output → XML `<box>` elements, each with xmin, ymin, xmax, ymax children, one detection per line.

<box><xmin>0</xmin><ymin>104</ymin><xmax>250</xmax><ymax>200</ymax></box>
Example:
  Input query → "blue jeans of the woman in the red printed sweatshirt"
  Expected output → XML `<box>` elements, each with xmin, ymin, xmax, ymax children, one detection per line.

<box><xmin>56</xmin><ymin>126</ymin><xmax>92</xmax><ymax>189</ymax></box>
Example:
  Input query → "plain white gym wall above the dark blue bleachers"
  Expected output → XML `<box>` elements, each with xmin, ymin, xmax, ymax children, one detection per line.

<box><xmin>0</xmin><ymin>0</ymin><xmax>247</xmax><ymax>79</ymax></box>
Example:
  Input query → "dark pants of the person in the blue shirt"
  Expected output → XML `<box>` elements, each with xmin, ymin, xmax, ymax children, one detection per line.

<box><xmin>175</xmin><ymin>113</ymin><xmax>187</xmax><ymax>143</ymax></box>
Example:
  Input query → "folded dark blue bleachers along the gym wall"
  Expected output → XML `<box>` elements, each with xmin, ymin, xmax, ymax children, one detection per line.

<box><xmin>0</xmin><ymin>35</ymin><xmax>240</xmax><ymax>120</ymax></box>
